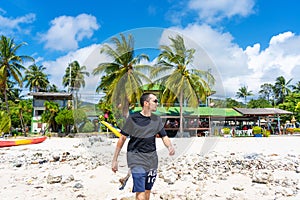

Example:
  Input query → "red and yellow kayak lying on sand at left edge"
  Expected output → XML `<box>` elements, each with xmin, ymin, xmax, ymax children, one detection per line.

<box><xmin>0</xmin><ymin>136</ymin><xmax>47</xmax><ymax>148</ymax></box>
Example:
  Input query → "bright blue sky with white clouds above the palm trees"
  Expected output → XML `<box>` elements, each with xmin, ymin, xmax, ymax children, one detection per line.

<box><xmin>0</xmin><ymin>0</ymin><xmax>300</xmax><ymax>101</ymax></box>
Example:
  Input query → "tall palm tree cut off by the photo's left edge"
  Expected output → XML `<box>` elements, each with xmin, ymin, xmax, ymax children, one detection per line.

<box><xmin>0</xmin><ymin>35</ymin><xmax>33</xmax><ymax>114</ymax></box>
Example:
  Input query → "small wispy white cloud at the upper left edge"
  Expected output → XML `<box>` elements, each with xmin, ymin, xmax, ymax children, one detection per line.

<box><xmin>0</xmin><ymin>10</ymin><xmax>36</xmax><ymax>34</ymax></box>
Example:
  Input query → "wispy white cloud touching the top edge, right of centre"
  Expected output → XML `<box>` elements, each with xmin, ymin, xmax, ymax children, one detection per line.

<box><xmin>188</xmin><ymin>0</ymin><xmax>255</xmax><ymax>24</ymax></box>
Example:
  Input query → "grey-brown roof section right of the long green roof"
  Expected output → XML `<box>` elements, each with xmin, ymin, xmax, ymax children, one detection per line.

<box><xmin>234</xmin><ymin>108</ymin><xmax>293</xmax><ymax>116</ymax></box>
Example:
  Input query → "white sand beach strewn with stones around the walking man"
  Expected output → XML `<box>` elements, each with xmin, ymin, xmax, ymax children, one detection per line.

<box><xmin>0</xmin><ymin>136</ymin><xmax>300</xmax><ymax>200</ymax></box>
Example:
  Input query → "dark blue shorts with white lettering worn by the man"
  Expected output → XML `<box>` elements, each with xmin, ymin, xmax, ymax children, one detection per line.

<box><xmin>131</xmin><ymin>167</ymin><xmax>157</xmax><ymax>192</ymax></box>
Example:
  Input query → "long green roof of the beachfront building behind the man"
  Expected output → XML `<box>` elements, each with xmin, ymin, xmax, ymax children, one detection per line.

<box><xmin>132</xmin><ymin>107</ymin><xmax>243</xmax><ymax>117</ymax></box>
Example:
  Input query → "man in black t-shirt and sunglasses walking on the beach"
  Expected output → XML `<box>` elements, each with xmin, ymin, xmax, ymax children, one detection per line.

<box><xmin>112</xmin><ymin>93</ymin><xmax>175</xmax><ymax>200</ymax></box>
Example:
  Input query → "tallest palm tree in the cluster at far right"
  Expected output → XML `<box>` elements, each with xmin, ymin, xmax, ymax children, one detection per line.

<box><xmin>274</xmin><ymin>76</ymin><xmax>292</xmax><ymax>104</ymax></box>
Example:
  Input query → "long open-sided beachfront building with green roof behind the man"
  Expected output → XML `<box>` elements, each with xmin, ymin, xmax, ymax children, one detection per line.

<box><xmin>131</xmin><ymin>106</ymin><xmax>292</xmax><ymax>137</ymax></box>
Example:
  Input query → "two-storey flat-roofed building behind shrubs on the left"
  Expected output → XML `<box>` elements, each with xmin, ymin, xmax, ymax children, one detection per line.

<box><xmin>28</xmin><ymin>92</ymin><xmax>73</xmax><ymax>133</ymax></box>
